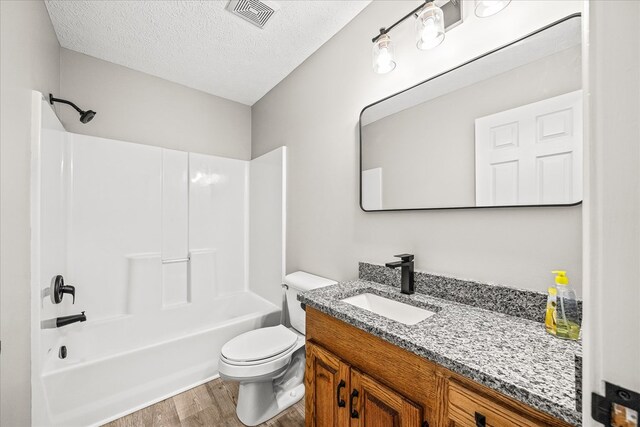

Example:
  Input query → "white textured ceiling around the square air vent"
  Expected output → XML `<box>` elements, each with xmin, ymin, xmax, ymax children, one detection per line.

<box><xmin>45</xmin><ymin>0</ymin><xmax>370</xmax><ymax>105</ymax></box>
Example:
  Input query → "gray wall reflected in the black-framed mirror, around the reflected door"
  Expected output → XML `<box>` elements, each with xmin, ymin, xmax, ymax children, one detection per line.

<box><xmin>362</xmin><ymin>46</ymin><xmax>582</xmax><ymax>209</ymax></box>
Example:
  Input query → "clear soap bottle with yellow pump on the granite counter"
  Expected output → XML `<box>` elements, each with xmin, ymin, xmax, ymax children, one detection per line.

<box><xmin>553</xmin><ymin>270</ymin><xmax>580</xmax><ymax>340</ymax></box>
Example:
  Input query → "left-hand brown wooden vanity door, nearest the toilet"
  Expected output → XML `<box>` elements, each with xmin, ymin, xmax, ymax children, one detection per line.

<box><xmin>305</xmin><ymin>342</ymin><xmax>350</xmax><ymax>427</ymax></box>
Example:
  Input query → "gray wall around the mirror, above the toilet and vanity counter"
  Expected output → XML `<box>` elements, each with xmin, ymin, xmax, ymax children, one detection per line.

<box><xmin>252</xmin><ymin>1</ymin><xmax>582</xmax><ymax>291</ymax></box>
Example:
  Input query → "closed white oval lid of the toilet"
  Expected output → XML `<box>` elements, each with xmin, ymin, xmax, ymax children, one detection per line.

<box><xmin>222</xmin><ymin>325</ymin><xmax>298</xmax><ymax>362</ymax></box>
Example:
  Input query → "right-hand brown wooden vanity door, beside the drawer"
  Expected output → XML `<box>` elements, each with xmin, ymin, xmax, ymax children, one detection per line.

<box><xmin>349</xmin><ymin>369</ymin><xmax>422</xmax><ymax>427</ymax></box>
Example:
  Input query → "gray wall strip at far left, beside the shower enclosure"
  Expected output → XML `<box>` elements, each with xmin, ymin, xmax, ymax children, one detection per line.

<box><xmin>0</xmin><ymin>1</ymin><xmax>60</xmax><ymax>427</ymax></box>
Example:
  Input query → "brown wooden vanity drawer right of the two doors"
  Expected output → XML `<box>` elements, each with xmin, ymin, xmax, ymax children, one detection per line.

<box><xmin>448</xmin><ymin>381</ymin><xmax>548</xmax><ymax>427</ymax></box>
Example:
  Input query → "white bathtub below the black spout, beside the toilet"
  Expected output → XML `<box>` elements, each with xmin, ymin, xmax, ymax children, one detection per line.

<box><xmin>42</xmin><ymin>292</ymin><xmax>280</xmax><ymax>427</ymax></box>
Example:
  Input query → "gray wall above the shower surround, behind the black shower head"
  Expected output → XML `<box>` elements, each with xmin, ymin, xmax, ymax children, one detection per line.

<box><xmin>56</xmin><ymin>49</ymin><xmax>251</xmax><ymax>160</ymax></box>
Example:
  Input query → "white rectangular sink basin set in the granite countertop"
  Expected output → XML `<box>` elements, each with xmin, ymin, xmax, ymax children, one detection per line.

<box><xmin>341</xmin><ymin>293</ymin><xmax>435</xmax><ymax>325</ymax></box>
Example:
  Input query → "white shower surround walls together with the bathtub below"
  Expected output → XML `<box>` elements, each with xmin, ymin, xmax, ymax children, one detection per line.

<box><xmin>32</xmin><ymin>93</ymin><xmax>285</xmax><ymax>426</ymax></box>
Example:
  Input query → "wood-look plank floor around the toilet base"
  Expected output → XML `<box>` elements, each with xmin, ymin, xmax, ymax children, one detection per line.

<box><xmin>104</xmin><ymin>378</ymin><xmax>304</xmax><ymax>427</ymax></box>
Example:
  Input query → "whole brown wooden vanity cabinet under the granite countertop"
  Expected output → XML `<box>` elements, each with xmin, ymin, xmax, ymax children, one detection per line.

<box><xmin>305</xmin><ymin>306</ymin><xmax>570</xmax><ymax>427</ymax></box>
